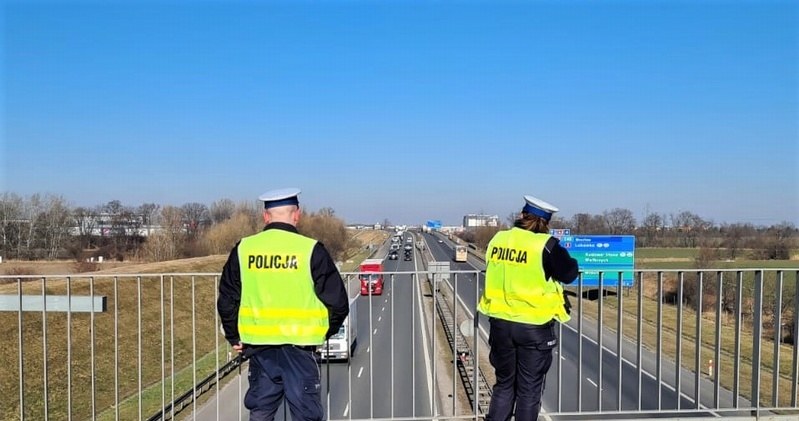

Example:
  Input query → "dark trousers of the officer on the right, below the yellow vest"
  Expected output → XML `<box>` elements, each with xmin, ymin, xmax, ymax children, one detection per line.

<box><xmin>486</xmin><ymin>317</ymin><xmax>558</xmax><ymax>421</ymax></box>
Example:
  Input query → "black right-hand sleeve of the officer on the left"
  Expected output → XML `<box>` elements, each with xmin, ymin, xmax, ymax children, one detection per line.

<box><xmin>311</xmin><ymin>242</ymin><xmax>350</xmax><ymax>339</ymax></box>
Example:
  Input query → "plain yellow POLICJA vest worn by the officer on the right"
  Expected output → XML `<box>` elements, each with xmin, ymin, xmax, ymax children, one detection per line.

<box><xmin>478</xmin><ymin>228</ymin><xmax>570</xmax><ymax>325</ymax></box>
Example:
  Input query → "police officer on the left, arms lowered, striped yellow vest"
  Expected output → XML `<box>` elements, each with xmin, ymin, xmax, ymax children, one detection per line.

<box><xmin>217</xmin><ymin>189</ymin><xmax>349</xmax><ymax>421</ymax></box>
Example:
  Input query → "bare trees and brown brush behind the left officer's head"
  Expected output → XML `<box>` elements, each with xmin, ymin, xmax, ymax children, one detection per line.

<box><xmin>0</xmin><ymin>192</ymin><xmax>352</xmax><ymax>262</ymax></box>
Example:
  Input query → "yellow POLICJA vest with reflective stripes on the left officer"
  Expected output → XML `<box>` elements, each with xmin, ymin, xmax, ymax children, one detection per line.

<box><xmin>238</xmin><ymin>229</ymin><xmax>329</xmax><ymax>345</ymax></box>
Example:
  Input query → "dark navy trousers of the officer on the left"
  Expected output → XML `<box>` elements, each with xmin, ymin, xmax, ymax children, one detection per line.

<box><xmin>244</xmin><ymin>345</ymin><xmax>324</xmax><ymax>421</ymax></box>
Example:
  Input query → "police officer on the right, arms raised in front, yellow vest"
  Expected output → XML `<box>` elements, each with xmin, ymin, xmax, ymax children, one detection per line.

<box><xmin>478</xmin><ymin>196</ymin><xmax>579</xmax><ymax>421</ymax></box>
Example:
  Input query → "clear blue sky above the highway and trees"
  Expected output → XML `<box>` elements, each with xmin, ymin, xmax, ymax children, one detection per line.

<box><xmin>0</xmin><ymin>0</ymin><xmax>799</xmax><ymax>225</ymax></box>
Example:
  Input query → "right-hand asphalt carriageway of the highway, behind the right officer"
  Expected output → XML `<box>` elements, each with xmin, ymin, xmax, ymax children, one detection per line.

<box><xmin>422</xmin><ymin>233</ymin><xmax>748</xmax><ymax>419</ymax></box>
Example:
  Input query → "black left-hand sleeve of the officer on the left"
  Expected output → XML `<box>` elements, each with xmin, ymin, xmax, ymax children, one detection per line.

<box><xmin>216</xmin><ymin>243</ymin><xmax>241</xmax><ymax>345</ymax></box>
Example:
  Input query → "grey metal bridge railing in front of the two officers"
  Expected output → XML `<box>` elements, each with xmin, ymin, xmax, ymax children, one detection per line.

<box><xmin>0</xmin><ymin>268</ymin><xmax>799</xmax><ymax>420</ymax></box>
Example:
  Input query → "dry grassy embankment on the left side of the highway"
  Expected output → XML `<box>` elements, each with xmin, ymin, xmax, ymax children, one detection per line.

<box><xmin>0</xmin><ymin>231</ymin><xmax>388</xmax><ymax>420</ymax></box>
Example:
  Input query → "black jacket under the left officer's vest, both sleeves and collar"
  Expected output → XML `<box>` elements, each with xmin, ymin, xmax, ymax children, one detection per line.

<box><xmin>216</xmin><ymin>222</ymin><xmax>350</xmax><ymax>345</ymax></box>
